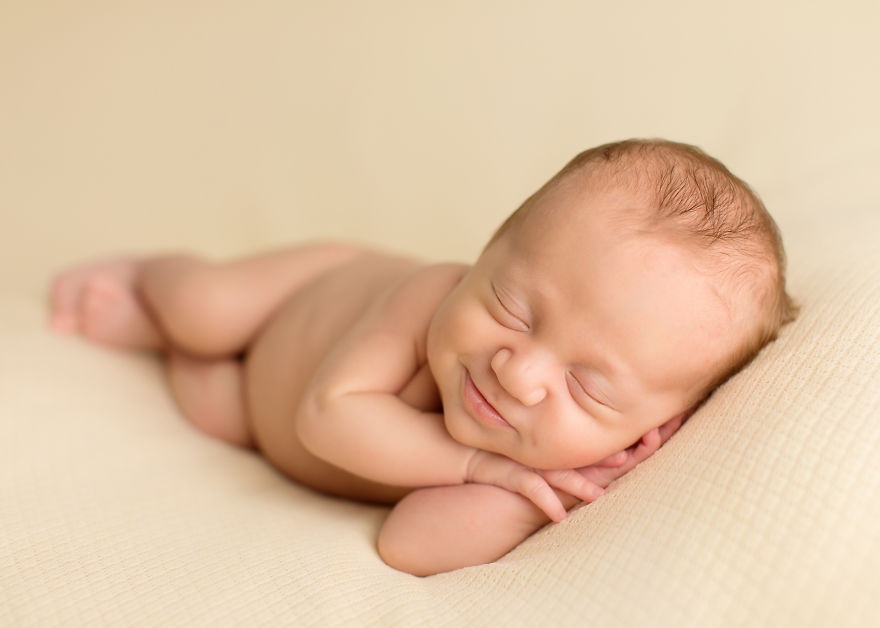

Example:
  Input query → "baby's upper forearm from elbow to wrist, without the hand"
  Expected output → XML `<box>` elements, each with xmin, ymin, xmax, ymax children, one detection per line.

<box><xmin>297</xmin><ymin>393</ymin><xmax>474</xmax><ymax>487</ymax></box>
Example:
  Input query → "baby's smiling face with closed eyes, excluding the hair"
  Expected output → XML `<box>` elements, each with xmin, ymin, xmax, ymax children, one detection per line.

<box><xmin>428</xmin><ymin>184</ymin><xmax>735</xmax><ymax>469</ymax></box>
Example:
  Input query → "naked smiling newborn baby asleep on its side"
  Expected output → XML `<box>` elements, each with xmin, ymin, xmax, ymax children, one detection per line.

<box><xmin>51</xmin><ymin>140</ymin><xmax>795</xmax><ymax>575</ymax></box>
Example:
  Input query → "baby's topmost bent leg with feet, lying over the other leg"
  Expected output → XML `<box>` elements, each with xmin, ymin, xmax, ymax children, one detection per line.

<box><xmin>50</xmin><ymin>244</ymin><xmax>359</xmax><ymax>358</ymax></box>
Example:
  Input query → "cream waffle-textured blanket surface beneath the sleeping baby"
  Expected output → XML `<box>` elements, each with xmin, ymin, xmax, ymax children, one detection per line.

<box><xmin>6</xmin><ymin>256</ymin><xmax>880</xmax><ymax>627</ymax></box>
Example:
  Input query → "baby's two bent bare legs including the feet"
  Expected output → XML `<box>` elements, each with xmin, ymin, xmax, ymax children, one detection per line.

<box><xmin>50</xmin><ymin>245</ymin><xmax>357</xmax><ymax>447</ymax></box>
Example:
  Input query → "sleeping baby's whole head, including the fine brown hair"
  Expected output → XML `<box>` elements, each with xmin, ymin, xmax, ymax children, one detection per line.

<box><xmin>429</xmin><ymin>140</ymin><xmax>795</xmax><ymax>468</ymax></box>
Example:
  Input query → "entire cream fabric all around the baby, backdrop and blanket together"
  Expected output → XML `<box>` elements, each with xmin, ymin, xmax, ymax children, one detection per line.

<box><xmin>0</xmin><ymin>0</ymin><xmax>880</xmax><ymax>628</ymax></box>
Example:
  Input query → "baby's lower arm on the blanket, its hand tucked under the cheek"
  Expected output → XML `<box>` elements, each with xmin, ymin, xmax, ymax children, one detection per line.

<box><xmin>378</xmin><ymin>417</ymin><xmax>682</xmax><ymax>576</ymax></box>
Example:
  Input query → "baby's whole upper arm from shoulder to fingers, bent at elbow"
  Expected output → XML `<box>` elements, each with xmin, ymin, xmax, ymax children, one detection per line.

<box><xmin>296</xmin><ymin>267</ymin><xmax>600</xmax><ymax>520</ymax></box>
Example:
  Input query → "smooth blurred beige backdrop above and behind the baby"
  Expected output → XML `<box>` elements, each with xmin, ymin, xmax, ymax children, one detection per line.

<box><xmin>0</xmin><ymin>0</ymin><xmax>880</xmax><ymax>285</ymax></box>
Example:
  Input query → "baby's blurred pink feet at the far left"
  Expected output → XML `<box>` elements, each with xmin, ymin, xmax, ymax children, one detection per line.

<box><xmin>49</xmin><ymin>259</ymin><xmax>161</xmax><ymax>348</ymax></box>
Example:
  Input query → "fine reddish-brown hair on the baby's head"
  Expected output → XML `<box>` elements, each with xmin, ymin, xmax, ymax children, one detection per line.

<box><xmin>490</xmin><ymin>139</ymin><xmax>798</xmax><ymax>390</ymax></box>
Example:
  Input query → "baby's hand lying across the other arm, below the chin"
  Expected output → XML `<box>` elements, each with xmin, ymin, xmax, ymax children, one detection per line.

<box><xmin>465</xmin><ymin>450</ymin><xmax>605</xmax><ymax>522</ymax></box>
